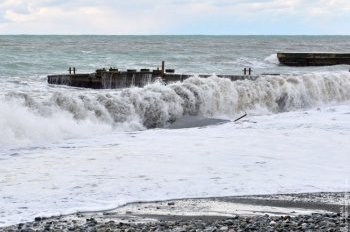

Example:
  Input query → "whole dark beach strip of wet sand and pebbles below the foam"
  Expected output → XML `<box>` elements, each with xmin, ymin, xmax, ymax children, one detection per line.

<box><xmin>0</xmin><ymin>192</ymin><xmax>350</xmax><ymax>232</ymax></box>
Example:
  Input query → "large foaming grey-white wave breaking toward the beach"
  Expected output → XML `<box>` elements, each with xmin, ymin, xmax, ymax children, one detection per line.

<box><xmin>0</xmin><ymin>72</ymin><xmax>350</xmax><ymax>144</ymax></box>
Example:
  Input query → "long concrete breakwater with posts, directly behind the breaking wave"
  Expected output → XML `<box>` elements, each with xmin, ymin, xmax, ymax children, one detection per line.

<box><xmin>48</xmin><ymin>62</ymin><xmax>257</xmax><ymax>89</ymax></box>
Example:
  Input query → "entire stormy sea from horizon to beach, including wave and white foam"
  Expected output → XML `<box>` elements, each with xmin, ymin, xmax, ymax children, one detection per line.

<box><xmin>0</xmin><ymin>35</ymin><xmax>350</xmax><ymax>227</ymax></box>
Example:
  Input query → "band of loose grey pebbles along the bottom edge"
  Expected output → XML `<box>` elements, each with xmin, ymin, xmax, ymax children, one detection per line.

<box><xmin>4</xmin><ymin>214</ymin><xmax>349</xmax><ymax>232</ymax></box>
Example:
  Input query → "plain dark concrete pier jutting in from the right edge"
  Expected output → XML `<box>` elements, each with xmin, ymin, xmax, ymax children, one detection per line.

<box><xmin>277</xmin><ymin>52</ymin><xmax>350</xmax><ymax>66</ymax></box>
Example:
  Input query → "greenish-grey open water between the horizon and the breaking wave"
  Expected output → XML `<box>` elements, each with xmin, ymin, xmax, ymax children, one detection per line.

<box><xmin>0</xmin><ymin>35</ymin><xmax>350</xmax><ymax>77</ymax></box>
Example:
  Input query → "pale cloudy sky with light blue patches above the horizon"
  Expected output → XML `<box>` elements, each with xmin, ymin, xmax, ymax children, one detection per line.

<box><xmin>0</xmin><ymin>0</ymin><xmax>350</xmax><ymax>35</ymax></box>
